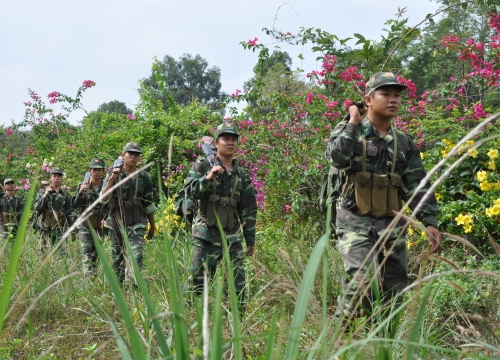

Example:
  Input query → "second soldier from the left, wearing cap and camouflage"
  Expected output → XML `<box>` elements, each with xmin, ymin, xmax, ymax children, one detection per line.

<box><xmin>35</xmin><ymin>167</ymin><xmax>75</xmax><ymax>253</ymax></box>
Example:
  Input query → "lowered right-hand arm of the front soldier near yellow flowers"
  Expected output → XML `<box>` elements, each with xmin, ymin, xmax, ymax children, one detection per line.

<box><xmin>403</xmin><ymin>137</ymin><xmax>439</xmax><ymax>227</ymax></box>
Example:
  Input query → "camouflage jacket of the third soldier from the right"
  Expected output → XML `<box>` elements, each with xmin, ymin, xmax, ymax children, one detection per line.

<box><xmin>101</xmin><ymin>169</ymin><xmax>156</xmax><ymax>228</ymax></box>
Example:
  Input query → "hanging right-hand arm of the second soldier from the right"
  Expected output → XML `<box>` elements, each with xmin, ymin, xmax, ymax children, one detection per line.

<box><xmin>238</xmin><ymin>174</ymin><xmax>257</xmax><ymax>247</ymax></box>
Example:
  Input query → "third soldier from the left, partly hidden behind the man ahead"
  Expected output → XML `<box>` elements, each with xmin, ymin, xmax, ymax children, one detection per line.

<box><xmin>73</xmin><ymin>158</ymin><xmax>105</xmax><ymax>275</ymax></box>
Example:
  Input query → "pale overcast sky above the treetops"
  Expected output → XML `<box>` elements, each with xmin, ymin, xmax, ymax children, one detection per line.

<box><xmin>0</xmin><ymin>0</ymin><xmax>438</xmax><ymax>126</ymax></box>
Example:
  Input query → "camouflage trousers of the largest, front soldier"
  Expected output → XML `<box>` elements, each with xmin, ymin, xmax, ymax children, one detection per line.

<box><xmin>335</xmin><ymin>227</ymin><xmax>408</xmax><ymax>318</ymax></box>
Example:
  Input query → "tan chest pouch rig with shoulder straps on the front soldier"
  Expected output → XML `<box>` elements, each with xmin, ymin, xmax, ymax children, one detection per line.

<box><xmin>343</xmin><ymin>130</ymin><xmax>408</xmax><ymax>218</ymax></box>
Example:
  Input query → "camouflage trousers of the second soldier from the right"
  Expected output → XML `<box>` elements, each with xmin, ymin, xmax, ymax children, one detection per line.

<box><xmin>191</xmin><ymin>239</ymin><xmax>245</xmax><ymax>302</ymax></box>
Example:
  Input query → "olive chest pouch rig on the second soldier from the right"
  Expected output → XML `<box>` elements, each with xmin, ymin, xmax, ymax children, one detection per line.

<box><xmin>198</xmin><ymin>175</ymin><xmax>238</xmax><ymax>230</ymax></box>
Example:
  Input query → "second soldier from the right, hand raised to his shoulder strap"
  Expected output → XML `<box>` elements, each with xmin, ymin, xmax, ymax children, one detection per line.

<box><xmin>186</xmin><ymin>122</ymin><xmax>257</xmax><ymax>304</ymax></box>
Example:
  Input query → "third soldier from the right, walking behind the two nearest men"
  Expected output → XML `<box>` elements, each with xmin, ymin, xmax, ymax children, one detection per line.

<box><xmin>102</xmin><ymin>142</ymin><xmax>156</xmax><ymax>282</ymax></box>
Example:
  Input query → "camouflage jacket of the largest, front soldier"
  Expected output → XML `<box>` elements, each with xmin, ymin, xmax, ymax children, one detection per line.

<box><xmin>325</xmin><ymin>117</ymin><xmax>439</xmax><ymax>237</ymax></box>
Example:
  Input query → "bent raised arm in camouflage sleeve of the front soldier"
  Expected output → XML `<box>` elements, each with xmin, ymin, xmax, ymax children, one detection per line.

<box><xmin>325</xmin><ymin>120</ymin><xmax>358</xmax><ymax>170</ymax></box>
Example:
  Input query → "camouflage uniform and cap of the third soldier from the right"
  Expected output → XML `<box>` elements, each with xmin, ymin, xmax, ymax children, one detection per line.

<box><xmin>103</xmin><ymin>143</ymin><xmax>156</xmax><ymax>282</ymax></box>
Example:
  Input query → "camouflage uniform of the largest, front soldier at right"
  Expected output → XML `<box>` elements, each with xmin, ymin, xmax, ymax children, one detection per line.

<box><xmin>325</xmin><ymin>71</ymin><xmax>439</xmax><ymax>317</ymax></box>
